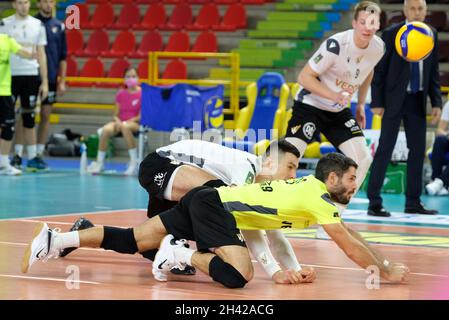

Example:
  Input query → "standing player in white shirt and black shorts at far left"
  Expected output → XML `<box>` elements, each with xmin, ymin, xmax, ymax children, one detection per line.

<box><xmin>3</xmin><ymin>0</ymin><xmax>48</xmax><ymax>171</ymax></box>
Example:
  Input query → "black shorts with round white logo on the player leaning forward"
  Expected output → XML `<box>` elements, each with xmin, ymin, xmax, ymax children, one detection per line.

<box><xmin>286</xmin><ymin>101</ymin><xmax>363</xmax><ymax>147</ymax></box>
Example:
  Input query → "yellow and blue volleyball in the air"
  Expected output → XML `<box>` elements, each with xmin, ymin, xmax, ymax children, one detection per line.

<box><xmin>395</xmin><ymin>21</ymin><xmax>434</xmax><ymax>62</ymax></box>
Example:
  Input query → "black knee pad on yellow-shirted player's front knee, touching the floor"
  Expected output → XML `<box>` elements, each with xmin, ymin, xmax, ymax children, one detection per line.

<box><xmin>209</xmin><ymin>256</ymin><xmax>248</xmax><ymax>289</ymax></box>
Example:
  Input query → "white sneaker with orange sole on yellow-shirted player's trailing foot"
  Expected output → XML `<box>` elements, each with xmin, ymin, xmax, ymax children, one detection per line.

<box><xmin>22</xmin><ymin>222</ymin><xmax>59</xmax><ymax>273</ymax></box>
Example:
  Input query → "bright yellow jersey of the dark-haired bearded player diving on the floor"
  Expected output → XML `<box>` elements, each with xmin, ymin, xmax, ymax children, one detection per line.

<box><xmin>217</xmin><ymin>175</ymin><xmax>341</xmax><ymax>230</ymax></box>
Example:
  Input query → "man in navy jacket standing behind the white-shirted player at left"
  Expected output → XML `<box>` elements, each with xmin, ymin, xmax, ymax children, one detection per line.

<box><xmin>34</xmin><ymin>0</ymin><xmax>67</xmax><ymax>165</ymax></box>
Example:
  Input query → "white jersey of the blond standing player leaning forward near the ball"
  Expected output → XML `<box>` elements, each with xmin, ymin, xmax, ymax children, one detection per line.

<box><xmin>295</xmin><ymin>29</ymin><xmax>385</xmax><ymax>112</ymax></box>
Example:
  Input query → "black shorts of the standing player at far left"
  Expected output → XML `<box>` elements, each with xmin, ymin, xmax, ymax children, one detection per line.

<box><xmin>11</xmin><ymin>76</ymin><xmax>40</xmax><ymax>110</ymax></box>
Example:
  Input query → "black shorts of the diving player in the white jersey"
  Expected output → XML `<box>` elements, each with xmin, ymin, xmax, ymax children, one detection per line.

<box><xmin>139</xmin><ymin>152</ymin><xmax>181</xmax><ymax>218</ymax></box>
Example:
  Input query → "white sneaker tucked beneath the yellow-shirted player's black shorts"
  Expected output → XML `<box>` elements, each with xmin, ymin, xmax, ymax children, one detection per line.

<box><xmin>152</xmin><ymin>234</ymin><xmax>187</xmax><ymax>281</ymax></box>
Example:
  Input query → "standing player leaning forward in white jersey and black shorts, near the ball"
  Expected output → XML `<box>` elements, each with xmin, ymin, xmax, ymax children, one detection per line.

<box><xmin>286</xmin><ymin>1</ymin><xmax>384</xmax><ymax>238</ymax></box>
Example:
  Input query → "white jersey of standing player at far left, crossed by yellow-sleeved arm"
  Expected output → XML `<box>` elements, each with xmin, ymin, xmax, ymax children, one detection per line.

<box><xmin>3</xmin><ymin>15</ymin><xmax>47</xmax><ymax>76</ymax></box>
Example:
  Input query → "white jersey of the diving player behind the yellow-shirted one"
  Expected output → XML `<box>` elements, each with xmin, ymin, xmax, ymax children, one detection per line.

<box><xmin>156</xmin><ymin>140</ymin><xmax>262</xmax><ymax>185</ymax></box>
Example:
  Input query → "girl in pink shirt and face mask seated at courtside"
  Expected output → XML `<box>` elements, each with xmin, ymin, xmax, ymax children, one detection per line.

<box><xmin>87</xmin><ymin>67</ymin><xmax>142</xmax><ymax>175</ymax></box>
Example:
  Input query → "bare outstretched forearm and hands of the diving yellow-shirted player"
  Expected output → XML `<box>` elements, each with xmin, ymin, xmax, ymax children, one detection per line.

<box><xmin>323</xmin><ymin>223</ymin><xmax>410</xmax><ymax>283</ymax></box>
